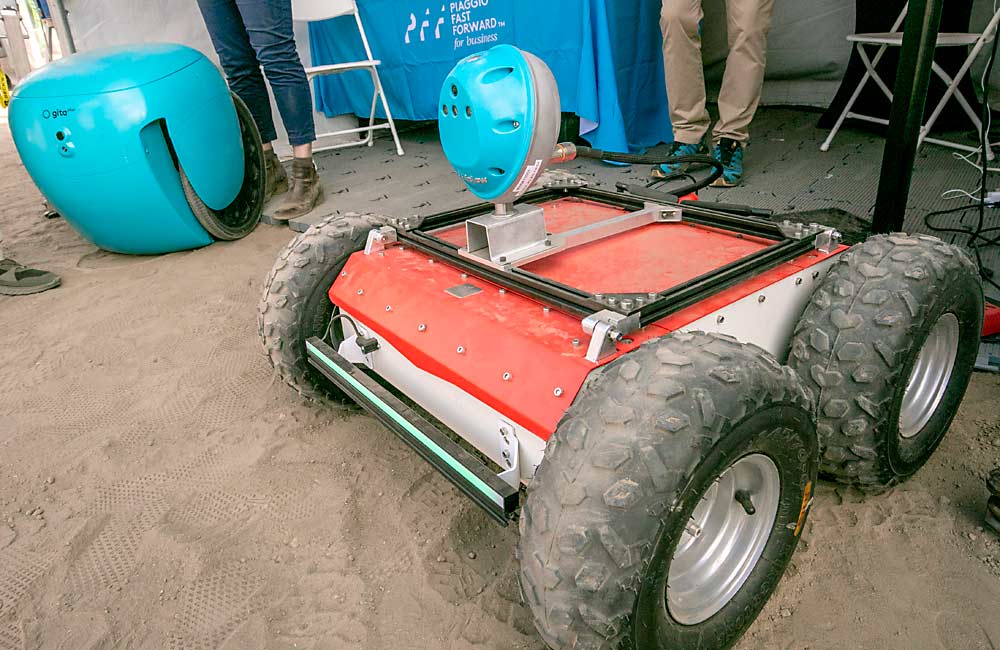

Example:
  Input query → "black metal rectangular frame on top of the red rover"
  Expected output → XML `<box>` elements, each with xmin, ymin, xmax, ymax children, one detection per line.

<box><xmin>398</xmin><ymin>186</ymin><xmax>814</xmax><ymax>326</ymax></box>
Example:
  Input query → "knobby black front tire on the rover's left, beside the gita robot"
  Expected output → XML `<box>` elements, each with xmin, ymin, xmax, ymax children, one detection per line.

<box><xmin>257</xmin><ymin>215</ymin><xmax>373</xmax><ymax>404</ymax></box>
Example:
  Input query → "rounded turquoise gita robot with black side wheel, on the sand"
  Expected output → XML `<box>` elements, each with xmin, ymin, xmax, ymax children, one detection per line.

<box><xmin>10</xmin><ymin>44</ymin><xmax>265</xmax><ymax>254</ymax></box>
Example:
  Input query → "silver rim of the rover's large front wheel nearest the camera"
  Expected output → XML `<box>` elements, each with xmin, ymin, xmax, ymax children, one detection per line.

<box><xmin>666</xmin><ymin>454</ymin><xmax>781</xmax><ymax>625</ymax></box>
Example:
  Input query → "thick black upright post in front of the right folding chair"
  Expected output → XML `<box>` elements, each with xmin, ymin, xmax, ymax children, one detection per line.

<box><xmin>872</xmin><ymin>0</ymin><xmax>944</xmax><ymax>233</ymax></box>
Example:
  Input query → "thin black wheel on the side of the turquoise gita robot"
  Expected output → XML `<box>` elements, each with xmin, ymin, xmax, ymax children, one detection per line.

<box><xmin>179</xmin><ymin>93</ymin><xmax>266</xmax><ymax>240</ymax></box>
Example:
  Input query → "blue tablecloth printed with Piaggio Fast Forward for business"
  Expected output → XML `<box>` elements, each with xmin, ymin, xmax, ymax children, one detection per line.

<box><xmin>309</xmin><ymin>0</ymin><xmax>672</xmax><ymax>151</ymax></box>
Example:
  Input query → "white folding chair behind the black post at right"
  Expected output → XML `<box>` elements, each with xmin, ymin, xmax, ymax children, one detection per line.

<box><xmin>820</xmin><ymin>4</ymin><xmax>1000</xmax><ymax>160</ymax></box>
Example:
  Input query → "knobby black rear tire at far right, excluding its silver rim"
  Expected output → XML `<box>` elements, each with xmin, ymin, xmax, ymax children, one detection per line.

<box><xmin>788</xmin><ymin>234</ymin><xmax>983</xmax><ymax>490</ymax></box>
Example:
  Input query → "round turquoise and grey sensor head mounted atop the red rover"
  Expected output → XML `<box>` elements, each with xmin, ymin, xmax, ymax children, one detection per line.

<box><xmin>438</xmin><ymin>45</ymin><xmax>560</xmax><ymax>204</ymax></box>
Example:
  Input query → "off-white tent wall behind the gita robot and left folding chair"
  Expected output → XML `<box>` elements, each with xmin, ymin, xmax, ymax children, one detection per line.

<box><xmin>58</xmin><ymin>0</ymin><xmax>357</xmax><ymax>157</ymax></box>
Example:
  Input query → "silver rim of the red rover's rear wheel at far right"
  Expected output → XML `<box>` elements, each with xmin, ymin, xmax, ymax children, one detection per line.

<box><xmin>899</xmin><ymin>314</ymin><xmax>959</xmax><ymax>438</ymax></box>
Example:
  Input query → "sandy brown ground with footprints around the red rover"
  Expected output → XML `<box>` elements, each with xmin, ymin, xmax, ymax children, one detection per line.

<box><xmin>0</xmin><ymin>125</ymin><xmax>1000</xmax><ymax>650</ymax></box>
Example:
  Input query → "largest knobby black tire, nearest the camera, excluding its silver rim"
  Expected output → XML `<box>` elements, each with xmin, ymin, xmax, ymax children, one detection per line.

<box><xmin>518</xmin><ymin>333</ymin><xmax>818</xmax><ymax>650</ymax></box>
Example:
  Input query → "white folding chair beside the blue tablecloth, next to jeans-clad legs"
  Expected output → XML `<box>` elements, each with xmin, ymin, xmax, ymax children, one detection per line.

<box><xmin>292</xmin><ymin>0</ymin><xmax>403</xmax><ymax>156</ymax></box>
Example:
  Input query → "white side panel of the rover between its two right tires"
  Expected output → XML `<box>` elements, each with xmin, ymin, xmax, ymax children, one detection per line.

<box><xmin>681</xmin><ymin>256</ymin><xmax>838</xmax><ymax>363</ymax></box>
